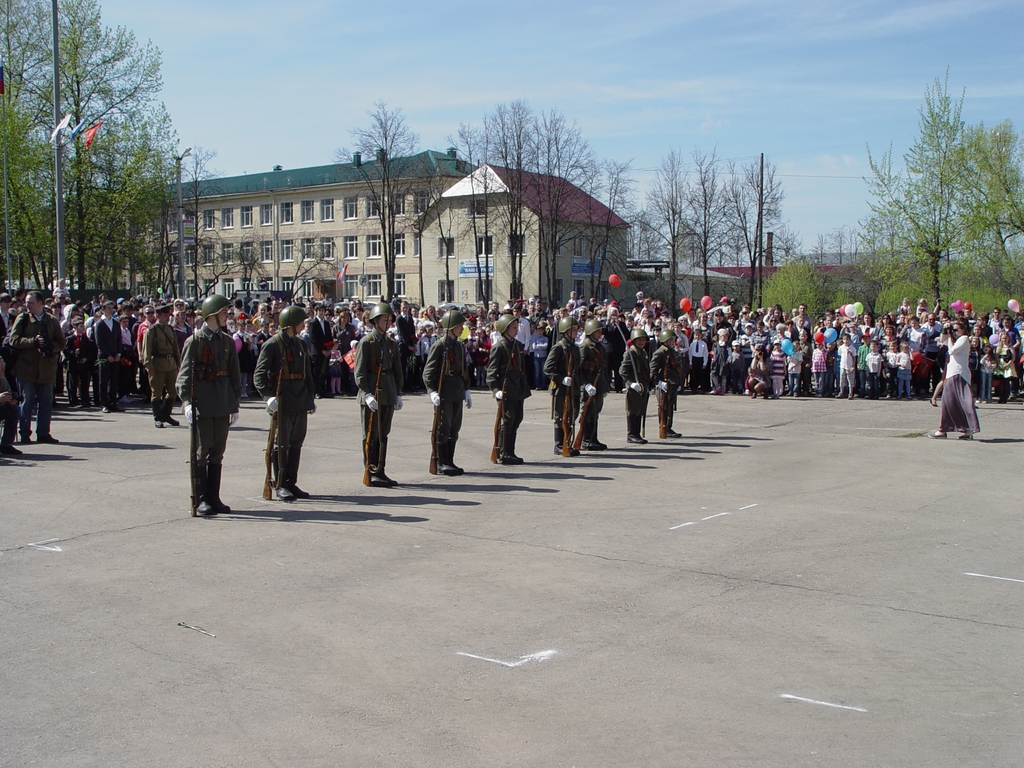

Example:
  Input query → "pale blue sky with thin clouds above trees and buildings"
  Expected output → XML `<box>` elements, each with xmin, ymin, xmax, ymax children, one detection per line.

<box><xmin>100</xmin><ymin>0</ymin><xmax>1024</xmax><ymax>248</ymax></box>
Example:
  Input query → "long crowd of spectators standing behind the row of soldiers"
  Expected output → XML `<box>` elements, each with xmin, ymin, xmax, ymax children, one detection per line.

<box><xmin>0</xmin><ymin>290</ymin><xmax>1024</xmax><ymax>454</ymax></box>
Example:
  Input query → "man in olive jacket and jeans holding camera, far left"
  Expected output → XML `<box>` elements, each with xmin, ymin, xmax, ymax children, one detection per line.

<box><xmin>7</xmin><ymin>291</ymin><xmax>65</xmax><ymax>443</ymax></box>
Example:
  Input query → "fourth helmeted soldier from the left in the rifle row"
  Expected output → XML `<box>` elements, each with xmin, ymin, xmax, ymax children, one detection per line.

<box><xmin>423</xmin><ymin>309</ymin><xmax>473</xmax><ymax>475</ymax></box>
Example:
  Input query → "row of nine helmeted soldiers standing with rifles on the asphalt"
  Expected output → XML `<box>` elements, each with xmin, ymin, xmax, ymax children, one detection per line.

<box><xmin>172</xmin><ymin>296</ymin><xmax>683</xmax><ymax>515</ymax></box>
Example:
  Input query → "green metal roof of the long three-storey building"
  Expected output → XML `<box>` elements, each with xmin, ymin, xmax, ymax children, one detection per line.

<box><xmin>193</xmin><ymin>150</ymin><xmax>473</xmax><ymax>197</ymax></box>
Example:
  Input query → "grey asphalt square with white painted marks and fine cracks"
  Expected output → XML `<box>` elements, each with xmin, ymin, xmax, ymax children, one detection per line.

<box><xmin>0</xmin><ymin>393</ymin><xmax>1024</xmax><ymax>767</ymax></box>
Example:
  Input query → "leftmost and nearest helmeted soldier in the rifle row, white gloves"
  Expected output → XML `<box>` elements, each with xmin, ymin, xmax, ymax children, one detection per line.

<box><xmin>177</xmin><ymin>295</ymin><xmax>242</xmax><ymax>515</ymax></box>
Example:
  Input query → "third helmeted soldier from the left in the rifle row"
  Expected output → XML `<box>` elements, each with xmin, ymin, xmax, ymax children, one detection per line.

<box><xmin>354</xmin><ymin>301</ymin><xmax>404</xmax><ymax>488</ymax></box>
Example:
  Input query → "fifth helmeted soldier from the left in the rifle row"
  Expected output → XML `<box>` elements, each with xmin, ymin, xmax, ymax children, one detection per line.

<box><xmin>487</xmin><ymin>312</ymin><xmax>531</xmax><ymax>464</ymax></box>
